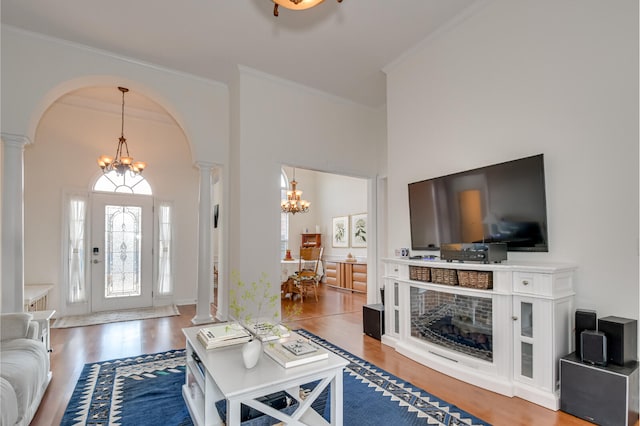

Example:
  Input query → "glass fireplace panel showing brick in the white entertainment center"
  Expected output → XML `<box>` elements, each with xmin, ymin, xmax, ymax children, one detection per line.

<box><xmin>410</xmin><ymin>286</ymin><xmax>493</xmax><ymax>362</ymax></box>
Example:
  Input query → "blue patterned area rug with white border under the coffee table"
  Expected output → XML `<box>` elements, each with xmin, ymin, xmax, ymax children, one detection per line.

<box><xmin>61</xmin><ymin>330</ymin><xmax>488</xmax><ymax>426</ymax></box>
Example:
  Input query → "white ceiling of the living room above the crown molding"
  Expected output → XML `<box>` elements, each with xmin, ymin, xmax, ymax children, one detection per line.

<box><xmin>1</xmin><ymin>0</ymin><xmax>483</xmax><ymax>107</ymax></box>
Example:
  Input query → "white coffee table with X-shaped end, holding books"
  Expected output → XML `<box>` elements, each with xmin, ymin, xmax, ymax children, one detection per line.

<box><xmin>182</xmin><ymin>327</ymin><xmax>348</xmax><ymax>426</ymax></box>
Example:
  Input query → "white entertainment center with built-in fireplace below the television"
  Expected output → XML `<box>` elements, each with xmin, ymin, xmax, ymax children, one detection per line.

<box><xmin>382</xmin><ymin>258</ymin><xmax>576</xmax><ymax>410</ymax></box>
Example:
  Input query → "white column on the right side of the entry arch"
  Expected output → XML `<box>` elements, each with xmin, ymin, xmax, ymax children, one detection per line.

<box><xmin>191</xmin><ymin>162</ymin><xmax>213</xmax><ymax>324</ymax></box>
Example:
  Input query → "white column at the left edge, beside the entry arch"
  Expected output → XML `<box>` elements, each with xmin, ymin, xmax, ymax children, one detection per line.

<box><xmin>0</xmin><ymin>133</ymin><xmax>29</xmax><ymax>313</ymax></box>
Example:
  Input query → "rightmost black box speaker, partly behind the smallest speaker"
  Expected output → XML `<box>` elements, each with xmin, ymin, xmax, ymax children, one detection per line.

<box><xmin>598</xmin><ymin>317</ymin><xmax>638</xmax><ymax>365</ymax></box>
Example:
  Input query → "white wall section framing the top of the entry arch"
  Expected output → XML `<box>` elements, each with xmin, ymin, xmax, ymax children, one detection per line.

<box><xmin>1</xmin><ymin>25</ymin><xmax>229</xmax><ymax>163</ymax></box>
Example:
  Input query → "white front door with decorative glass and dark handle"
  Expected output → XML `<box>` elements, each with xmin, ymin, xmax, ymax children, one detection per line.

<box><xmin>91</xmin><ymin>193</ymin><xmax>153</xmax><ymax>312</ymax></box>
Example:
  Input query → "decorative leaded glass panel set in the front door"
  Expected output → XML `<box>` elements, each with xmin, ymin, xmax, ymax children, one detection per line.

<box><xmin>104</xmin><ymin>205</ymin><xmax>142</xmax><ymax>298</ymax></box>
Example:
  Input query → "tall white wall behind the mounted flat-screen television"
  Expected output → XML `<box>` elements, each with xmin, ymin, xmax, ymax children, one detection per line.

<box><xmin>387</xmin><ymin>0</ymin><xmax>639</xmax><ymax>318</ymax></box>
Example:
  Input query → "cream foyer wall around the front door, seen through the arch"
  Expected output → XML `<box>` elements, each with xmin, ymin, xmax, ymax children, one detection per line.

<box><xmin>24</xmin><ymin>95</ymin><xmax>198</xmax><ymax>310</ymax></box>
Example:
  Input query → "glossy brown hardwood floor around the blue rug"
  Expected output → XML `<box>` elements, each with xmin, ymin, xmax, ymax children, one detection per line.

<box><xmin>31</xmin><ymin>285</ymin><xmax>589</xmax><ymax>426</ymax></box>
